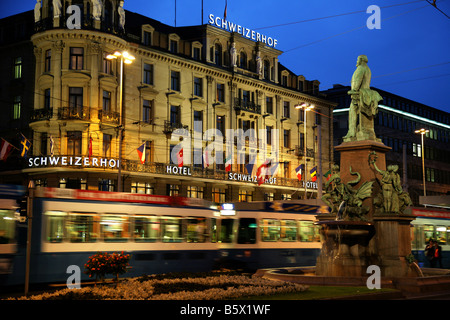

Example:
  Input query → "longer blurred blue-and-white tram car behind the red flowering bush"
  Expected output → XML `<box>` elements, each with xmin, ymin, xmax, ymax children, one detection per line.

<box><xmin>3</xmin><ymin>188</ymin><xmax>219</xmax><ymax>285</ymax></box>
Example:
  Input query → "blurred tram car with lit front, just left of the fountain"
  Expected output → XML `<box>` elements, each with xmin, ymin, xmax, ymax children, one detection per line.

<box><xmin>214</xmin><ymin>201</ymin><xmax>328</xmax><ymax>270</ymax></box>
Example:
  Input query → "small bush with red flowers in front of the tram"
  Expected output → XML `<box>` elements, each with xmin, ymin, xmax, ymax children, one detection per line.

<box><xmin>84</xmin><ymin>251</ymin><xmax>130</xmax><ymax>280</ymax></box>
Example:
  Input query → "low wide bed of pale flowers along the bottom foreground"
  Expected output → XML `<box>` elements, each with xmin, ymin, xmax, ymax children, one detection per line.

<box><xmin>8</xmin><ymin>275</ymin><xmax>308</xmax><ymax>300</ymax></box>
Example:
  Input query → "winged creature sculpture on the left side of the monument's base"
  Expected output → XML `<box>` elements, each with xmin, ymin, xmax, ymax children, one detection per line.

<box><xmin>322</xmin><ymin>165</ymin><xmax>373</xmax><ymax>220</ymax></box>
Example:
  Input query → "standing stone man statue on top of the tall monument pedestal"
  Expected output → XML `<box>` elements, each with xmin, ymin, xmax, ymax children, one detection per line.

<box><xmin>344</xmin><ymin>55</ymin><xmax>383</xmax><ymax>142</ymax></box>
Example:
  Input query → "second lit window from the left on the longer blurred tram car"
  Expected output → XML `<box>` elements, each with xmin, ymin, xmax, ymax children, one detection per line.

<box><xmin>67</xmin><ymin>214</ymin><xmax>98</xmax><ymax>242</ymax></box>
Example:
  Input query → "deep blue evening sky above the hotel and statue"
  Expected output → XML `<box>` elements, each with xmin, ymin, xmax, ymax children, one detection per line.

<box><xmin>0</xmin><ymin>0</ymin><xmax>450</xmax><ymax>112</ymax></box>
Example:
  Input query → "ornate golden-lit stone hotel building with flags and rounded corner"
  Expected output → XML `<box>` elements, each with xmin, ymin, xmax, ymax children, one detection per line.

<box><xmin>0</xmin><ymin>0</ymin><xmax>335</xmax><ymax>203</ymax></box>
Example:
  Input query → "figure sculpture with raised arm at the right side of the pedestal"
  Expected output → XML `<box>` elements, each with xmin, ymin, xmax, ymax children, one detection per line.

<box><xmin>369</xmin><ymin>151</ymin><xmax>412</xmax><ymax>214</ymax></box>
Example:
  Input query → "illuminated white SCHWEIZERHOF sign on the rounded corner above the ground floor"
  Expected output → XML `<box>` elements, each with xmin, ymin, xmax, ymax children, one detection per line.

<box><xmin>28</xmin><ymin>156</ymin><xmax>119</xmax><ymax>168</ymax></box>
